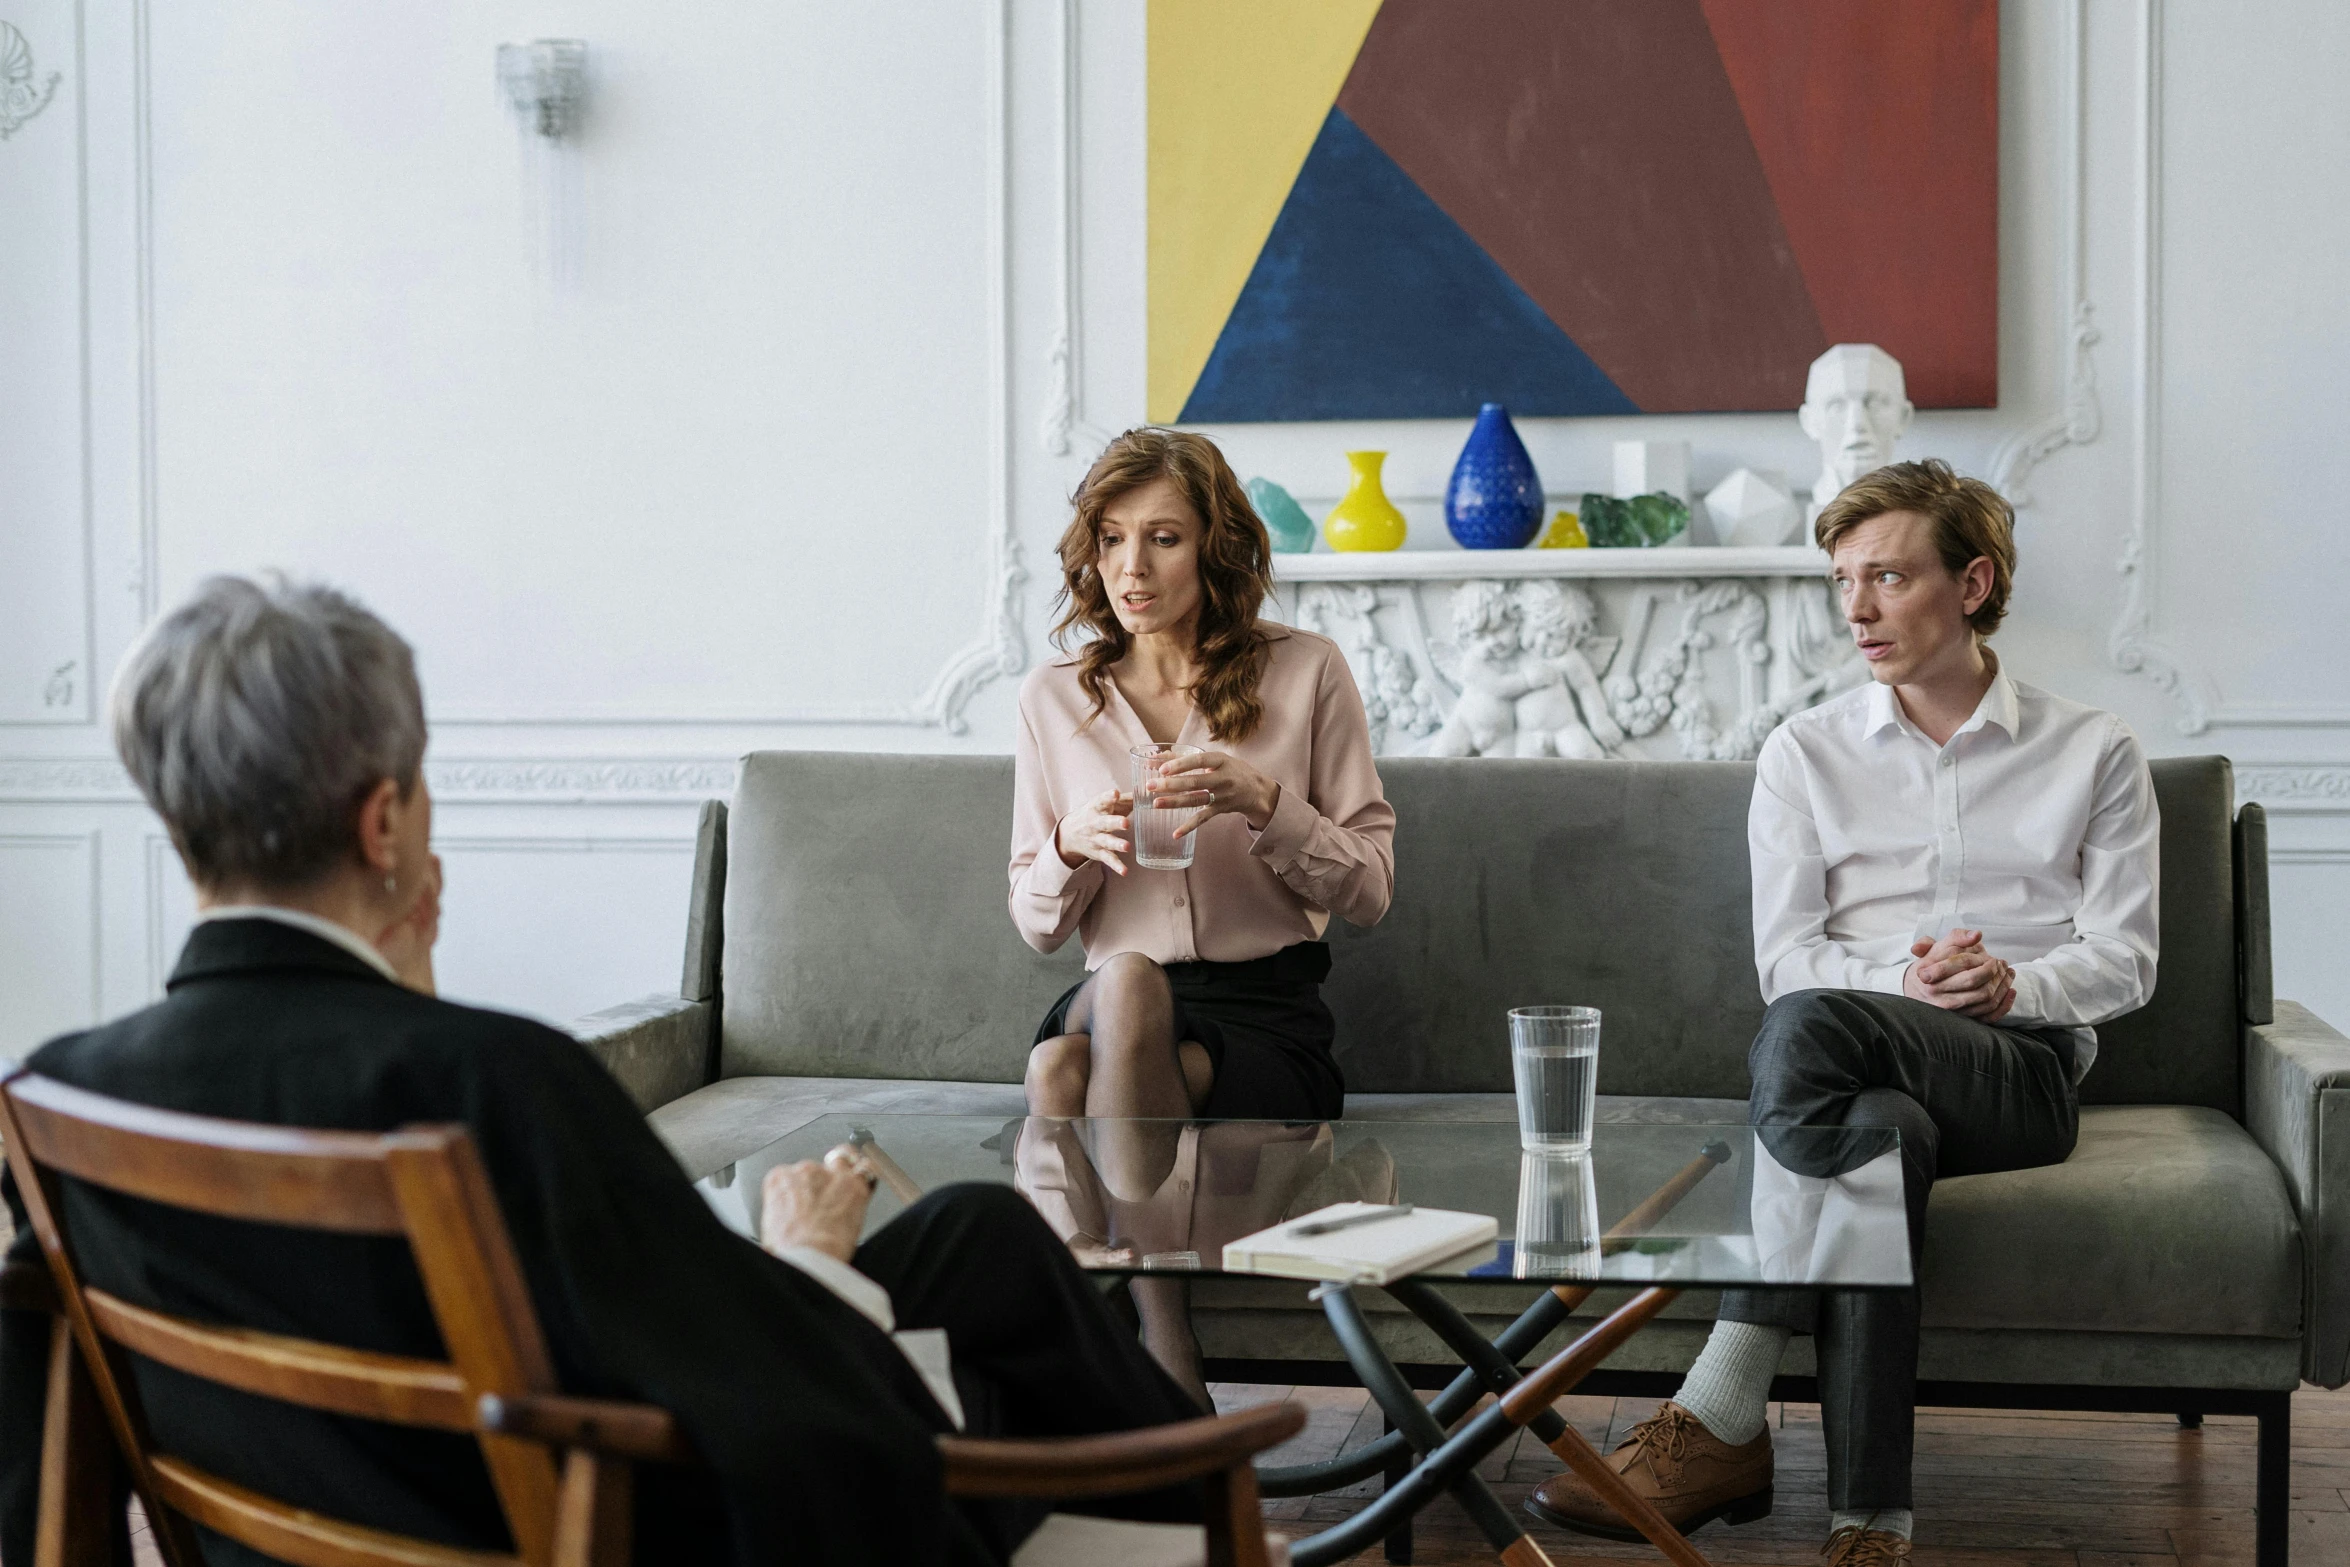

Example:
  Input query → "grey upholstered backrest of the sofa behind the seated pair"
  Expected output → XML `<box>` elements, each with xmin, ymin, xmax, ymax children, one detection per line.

<box><xmin>698</xmin><ymin>752</ymin><xmax>2265</xmax><ymax>1114</ymax></box>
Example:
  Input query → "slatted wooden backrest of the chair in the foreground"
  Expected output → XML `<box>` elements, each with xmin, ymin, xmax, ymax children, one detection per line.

<box><xmin>0</xmin><ymin>1071</ymin><xmax>658</xmax><ymax>1567</ymax></box>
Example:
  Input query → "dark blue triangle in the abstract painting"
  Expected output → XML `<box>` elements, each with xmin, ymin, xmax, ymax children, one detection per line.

<box><xmin>1182</xmin><ymin>108</ymin><xmax>1640</xmax><ymax>423</ymax></box>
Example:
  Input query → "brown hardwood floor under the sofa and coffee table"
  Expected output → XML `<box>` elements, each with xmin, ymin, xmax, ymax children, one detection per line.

<box><xmin>1215</xmin><ymin>1384</ymin><xmax>2350</xmax><ymax>1567</ymax></box>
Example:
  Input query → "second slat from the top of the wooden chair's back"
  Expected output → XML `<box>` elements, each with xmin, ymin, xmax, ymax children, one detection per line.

<box><xmin>82</xmin><ymin>1285</ymin><xmax>475</xmax><ymax>1431</ymax></box>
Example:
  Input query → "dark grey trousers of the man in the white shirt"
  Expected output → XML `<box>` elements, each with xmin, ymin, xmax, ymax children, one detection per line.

<box><xmin>1720</xmin><ymin>991</ymin><xmax>2080</xmax><ymax>1513</ymax></box>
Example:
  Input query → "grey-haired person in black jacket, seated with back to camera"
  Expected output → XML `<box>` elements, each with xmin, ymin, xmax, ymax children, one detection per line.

<box><xmin>0</xmin><ymin>578</ymin><xmax>1199</xmax><ymax>1567</ymax></box>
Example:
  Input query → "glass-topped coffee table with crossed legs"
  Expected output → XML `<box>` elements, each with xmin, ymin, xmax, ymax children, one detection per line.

<box><xmin>700</xmin><ymin>1114</ymin><xmax>1911</xmax><ymax>1567</ymax></box>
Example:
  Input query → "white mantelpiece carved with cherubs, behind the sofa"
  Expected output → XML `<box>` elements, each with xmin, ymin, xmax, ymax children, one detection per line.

<box><xmin>1274</xmin><ymin>545</ymin><xmax>1866</xmax><ymax>761</ymax></box>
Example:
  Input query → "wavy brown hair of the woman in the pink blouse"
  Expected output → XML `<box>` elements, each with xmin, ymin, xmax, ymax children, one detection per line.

<box><xmin>1053</xmin><ymin>425</ymin><xmax>1274</xmax><ymax>745</ymax></box>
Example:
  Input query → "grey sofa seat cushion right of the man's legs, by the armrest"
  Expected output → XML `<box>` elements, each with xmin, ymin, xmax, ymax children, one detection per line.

<box><xmin>1925</xmin><ymin>1104</ymin><xmax>2301</xmax><ymax>1339</ymax></box>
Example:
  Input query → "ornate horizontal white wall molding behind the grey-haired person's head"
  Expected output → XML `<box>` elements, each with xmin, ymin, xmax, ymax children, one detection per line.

<box><xmin>0</xmin><ymin>756</ymin><xmax>740</xmax><ymax>806</ymax></box>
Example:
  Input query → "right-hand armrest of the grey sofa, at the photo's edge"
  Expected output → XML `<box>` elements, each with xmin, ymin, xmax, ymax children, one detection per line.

<box><xmin>2244</xmin><ymin>1001</ymin><xmax>2350</xmax><ymax>1388</ymax></box>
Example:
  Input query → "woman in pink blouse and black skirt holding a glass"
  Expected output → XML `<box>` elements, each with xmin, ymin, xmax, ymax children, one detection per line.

<box><xmin>1011</xmin><ymin>430</ymin><xmax>1396</xmax><ymax>1386</ymax></box>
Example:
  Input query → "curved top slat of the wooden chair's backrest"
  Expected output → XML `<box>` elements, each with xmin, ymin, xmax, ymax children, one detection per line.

<box><xmin>9</xmin><ymin>1074</ymin><xmax>402</xmax><ymax>1236</ymax></box>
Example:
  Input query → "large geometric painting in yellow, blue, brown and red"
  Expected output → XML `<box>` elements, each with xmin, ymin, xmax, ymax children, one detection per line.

<box><xmin>1149</xmin><ymin>0</ymin><xmax>2000</xmax><ymax>423</ymax></box>
